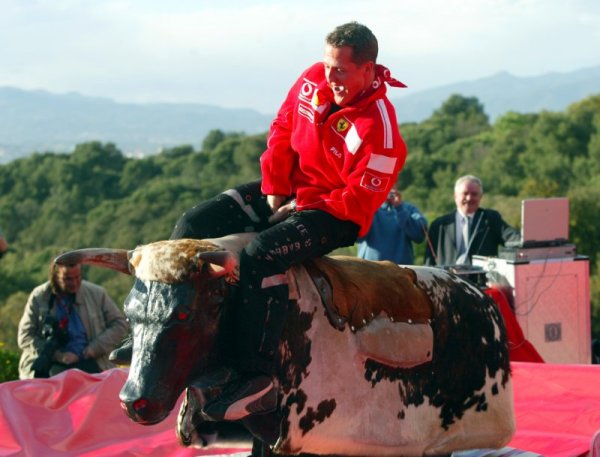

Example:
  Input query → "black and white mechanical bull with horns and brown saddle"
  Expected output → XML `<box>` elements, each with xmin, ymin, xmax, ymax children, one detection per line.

<box><xmin>57</xmin><ymin>235</ymin><xmax>515</xmax><ymax>456</ymax></box>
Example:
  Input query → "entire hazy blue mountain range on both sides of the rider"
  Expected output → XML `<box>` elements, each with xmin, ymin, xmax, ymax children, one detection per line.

<box><xmin>0</xmin><ymin>66</ymin><xmax>600</xmax><ymax>163</ymax></box>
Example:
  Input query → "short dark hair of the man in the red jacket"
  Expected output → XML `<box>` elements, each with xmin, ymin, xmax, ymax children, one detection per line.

<box><xmin>325</xmin><ymin>21</ymin><xmax>379</xmax><ymax>64</ymax></box>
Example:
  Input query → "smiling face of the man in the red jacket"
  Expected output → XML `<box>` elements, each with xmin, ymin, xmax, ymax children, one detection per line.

<box><xmin>323</xmin><ymin>44</ymin><xmax>375</xmax><ymax>106</ymax></box>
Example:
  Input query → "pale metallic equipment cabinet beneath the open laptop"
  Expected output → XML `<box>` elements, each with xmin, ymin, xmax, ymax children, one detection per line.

<box><xmin>473</xmin><ymin>256</ymin><xmax>591</xmax><ymax>363</ymax></box>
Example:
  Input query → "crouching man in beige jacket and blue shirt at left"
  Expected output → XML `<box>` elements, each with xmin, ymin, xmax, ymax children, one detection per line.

<box><xmin>17</xmin><ymin>262</ymin><xmax>128</xmax><ymax>379</ymax></box>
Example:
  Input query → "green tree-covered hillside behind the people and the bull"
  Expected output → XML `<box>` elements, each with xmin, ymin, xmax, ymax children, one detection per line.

<box><xmin>0</xmin><ymin>95</ymin><xmax>600</xmax><ymax>356</ymax></box>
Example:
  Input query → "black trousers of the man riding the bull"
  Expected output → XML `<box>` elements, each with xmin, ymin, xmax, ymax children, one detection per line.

<box><xmin>171</xmin><ymin>181</ymin><xmax>359</xmax><ymax>373</ymax></box>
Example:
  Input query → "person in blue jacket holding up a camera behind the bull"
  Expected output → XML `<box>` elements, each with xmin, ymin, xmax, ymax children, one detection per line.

<box><xmin>358</xmin><ymin>189</ymin><xmax>427</xmax><ymax>265</ymax></box>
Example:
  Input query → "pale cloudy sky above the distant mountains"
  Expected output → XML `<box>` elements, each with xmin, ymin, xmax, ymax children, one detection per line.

<box><xmin>0</xmin><ymin>0</ymin><xmax>600</xmax><ymax>113</ymax></box>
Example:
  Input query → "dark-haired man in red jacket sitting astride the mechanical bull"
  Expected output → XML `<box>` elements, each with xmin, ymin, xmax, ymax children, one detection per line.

<box><xmin>111</xmin><ymin>22</ymin><xmax>406</xmax><ymax>420</ymax></box>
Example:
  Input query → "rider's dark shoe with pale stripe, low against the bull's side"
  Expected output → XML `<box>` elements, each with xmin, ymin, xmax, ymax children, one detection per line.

<box><xmin>202</xmin><ymin>375</ymin><xmax>277</xmax><ymax>421</ymax></box>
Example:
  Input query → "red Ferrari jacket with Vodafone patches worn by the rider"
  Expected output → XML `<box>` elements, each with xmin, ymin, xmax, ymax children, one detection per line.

<box><xmin>260</xmin><ymin>63</ymin><xmax>406</xmax><ymax>236</ymax></box>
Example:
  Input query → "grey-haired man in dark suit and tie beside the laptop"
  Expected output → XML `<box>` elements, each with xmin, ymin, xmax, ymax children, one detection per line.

<box><xmin>425</xmin><ymin>175</ymin><xmax>520</xmax><ymax>265</ymax></box>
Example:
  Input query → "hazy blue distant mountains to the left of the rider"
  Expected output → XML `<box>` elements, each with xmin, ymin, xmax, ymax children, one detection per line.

<box><xmin>0</xmin><ymin>87</ymin><xmax>273</xmax><ymax>163</ymax></box>
